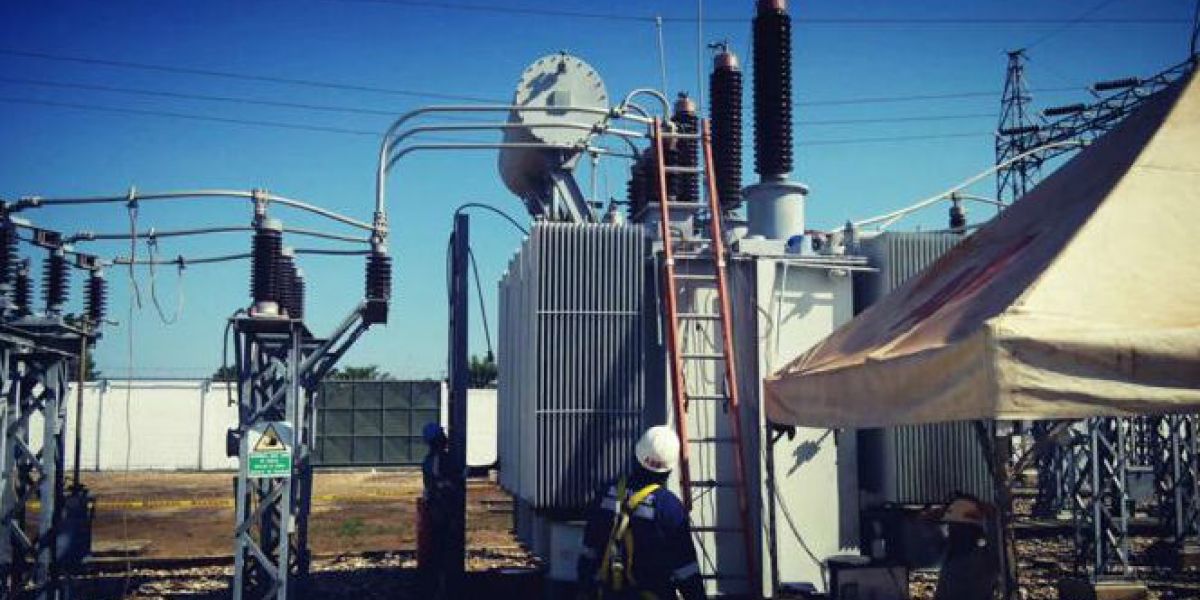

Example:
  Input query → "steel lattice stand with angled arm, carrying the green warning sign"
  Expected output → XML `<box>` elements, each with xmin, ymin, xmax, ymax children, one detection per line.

<box><xmin>230</xmin><ymin>304</ymin><xmax>368</xmax><ymax>600</ymax></box>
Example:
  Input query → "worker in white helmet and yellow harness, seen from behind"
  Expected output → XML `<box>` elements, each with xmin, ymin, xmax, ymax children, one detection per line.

<box><xmin>577</xmin><ymin>425</ymin><xmax>704</xmax><ymax>600</ymax></box>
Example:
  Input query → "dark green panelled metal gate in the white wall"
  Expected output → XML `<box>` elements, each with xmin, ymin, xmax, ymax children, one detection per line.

<box><xmin>313</xmin><ymin>380</ymin><xmax>442</xmax><ymax>467</ymax></box>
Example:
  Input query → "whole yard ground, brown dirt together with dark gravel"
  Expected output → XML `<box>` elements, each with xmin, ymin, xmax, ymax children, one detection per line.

<box><xmin>58</xmin><ymin>470</ymin><xmax>1200</xmax><ymax>600</ymax></box>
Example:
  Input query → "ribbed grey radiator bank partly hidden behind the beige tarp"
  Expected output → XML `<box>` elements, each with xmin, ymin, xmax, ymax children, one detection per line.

<box><xmin>854</xmin><ymin>232</ymin><xmax>992</xmax><ymax>504</ymax></box>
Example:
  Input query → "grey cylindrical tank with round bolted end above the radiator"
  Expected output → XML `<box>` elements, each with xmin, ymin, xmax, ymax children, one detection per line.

<box><xmin>499</xmin><ymin>53</ymin><xmax>610</xmax><ymax>216</ymax></box>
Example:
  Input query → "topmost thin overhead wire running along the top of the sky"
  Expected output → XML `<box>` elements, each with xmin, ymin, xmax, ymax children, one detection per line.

<box><xmin>328</xmin><ymin>0</ymin><xmax>1188</xmax><ymax>26</ymax></box>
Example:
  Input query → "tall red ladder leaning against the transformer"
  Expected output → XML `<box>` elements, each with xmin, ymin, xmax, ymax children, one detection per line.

<box><xmin>653</xmin><ymin>119</ymin><xmax>761</xmax><ymax>598</ymax></box>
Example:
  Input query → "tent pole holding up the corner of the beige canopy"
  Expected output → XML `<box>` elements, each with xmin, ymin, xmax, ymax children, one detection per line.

<box><xmin>974</xmin><ymin>420</ymin><xmax>1019</xmax><ymax>600</ymax></box>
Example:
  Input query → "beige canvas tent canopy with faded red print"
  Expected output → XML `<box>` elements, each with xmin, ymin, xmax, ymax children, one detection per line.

<box><xmin>766</xmin><ymin>69</ymin><xmax>1200</xmax><ymax>427</ymax></box>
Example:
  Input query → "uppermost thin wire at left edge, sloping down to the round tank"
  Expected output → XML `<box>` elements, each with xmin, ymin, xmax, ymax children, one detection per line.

<box><xmin>0</xmin><ymin>48</ymin><xmax>497</xmax><ymax>103</ymax></box>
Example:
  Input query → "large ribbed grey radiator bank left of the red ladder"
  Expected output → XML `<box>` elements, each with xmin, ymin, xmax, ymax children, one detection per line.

<box><xmin>498</xmin><ymin>223</ymin><xmax>653</xmax><ymax>512</ymax></box>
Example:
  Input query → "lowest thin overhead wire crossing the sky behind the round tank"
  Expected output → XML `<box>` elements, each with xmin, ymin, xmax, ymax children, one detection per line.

<box><xmin>0</xmin><ymin>95</ymin><xmax>992</xmax><ymax>148</ymax></box>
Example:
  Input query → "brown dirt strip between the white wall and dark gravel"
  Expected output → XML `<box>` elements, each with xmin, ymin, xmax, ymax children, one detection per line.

<box><xmin>84</xmin><ymin>470</ymin><xmax>516</xmax><ymax>558</ymax></box>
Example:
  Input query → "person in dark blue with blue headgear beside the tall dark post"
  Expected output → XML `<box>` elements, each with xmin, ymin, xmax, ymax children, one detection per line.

<box><xmin>418</xmin><ymin>422</ymin><xmax>457</xmax><ymax>598</ymax></box>
